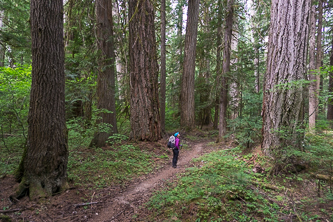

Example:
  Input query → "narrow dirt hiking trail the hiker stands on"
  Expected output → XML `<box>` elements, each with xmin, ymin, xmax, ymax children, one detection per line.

<box><xmin>89</xmin><ymin>143</ymin><xmax>204</xmax><ymax>222</ymax></box>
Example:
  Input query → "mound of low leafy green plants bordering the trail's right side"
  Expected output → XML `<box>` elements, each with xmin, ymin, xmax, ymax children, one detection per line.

<box><xmin>148</xmin><ymin>150</ymin><xmax>286</xmax><ymax>221</ymax></box>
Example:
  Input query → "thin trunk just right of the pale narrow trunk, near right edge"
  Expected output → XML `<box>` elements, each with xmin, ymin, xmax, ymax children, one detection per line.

<box><xmin>316</xmin><ymin>0</ymin><xmax>323</xmax><ymax>118</ymax></box>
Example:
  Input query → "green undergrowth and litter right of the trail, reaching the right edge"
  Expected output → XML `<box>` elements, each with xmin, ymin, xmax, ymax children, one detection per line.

<box><xmin>147</xmin><ymin>149</ymin><xmax>333</xmax><ymax>221</ymax></box>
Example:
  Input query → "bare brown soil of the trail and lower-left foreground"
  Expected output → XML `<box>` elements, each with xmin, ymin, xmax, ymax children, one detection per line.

<box><xmin>0</xmin><ymin>142</ymin><xmax>218</xmax><ymax>222</ymax></box>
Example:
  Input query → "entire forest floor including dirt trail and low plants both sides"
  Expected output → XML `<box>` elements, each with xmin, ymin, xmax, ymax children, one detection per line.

<box><xmin>0</xmin><ymin>132</ymin><xmax>333</xmax><ymax>222</ymax></box>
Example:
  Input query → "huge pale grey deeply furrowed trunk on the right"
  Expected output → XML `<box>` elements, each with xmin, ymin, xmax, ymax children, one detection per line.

<box><xmin>262</xmin><ymin>0</ymin><xmax>311</xmax><ymax>158</ymax></box>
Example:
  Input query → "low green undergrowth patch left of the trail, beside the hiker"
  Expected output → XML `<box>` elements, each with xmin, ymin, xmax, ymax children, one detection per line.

<box><xmin>68</xmin><ymin>144</ymin><xmax>164</xmax><ymax>188</ymax></box>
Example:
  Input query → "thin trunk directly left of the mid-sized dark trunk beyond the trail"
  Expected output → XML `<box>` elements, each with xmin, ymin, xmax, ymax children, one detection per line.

<box><xmin>213</xmin><ymin>0</ymin><xmax>222</xmax><ymax>129</ymax></box>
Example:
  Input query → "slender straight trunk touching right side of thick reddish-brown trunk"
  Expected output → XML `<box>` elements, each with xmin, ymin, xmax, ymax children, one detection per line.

<box><xmin>160</xmin><ymin>0</ymin><xmax>166</xmax><ymax>133</ymax></box>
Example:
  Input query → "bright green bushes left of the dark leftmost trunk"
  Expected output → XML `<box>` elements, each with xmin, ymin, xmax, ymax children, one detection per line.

<box><xmin>0</xmin><ymin>65</ymin><xmax>31</xmax><ymax>175</ymax></box>
